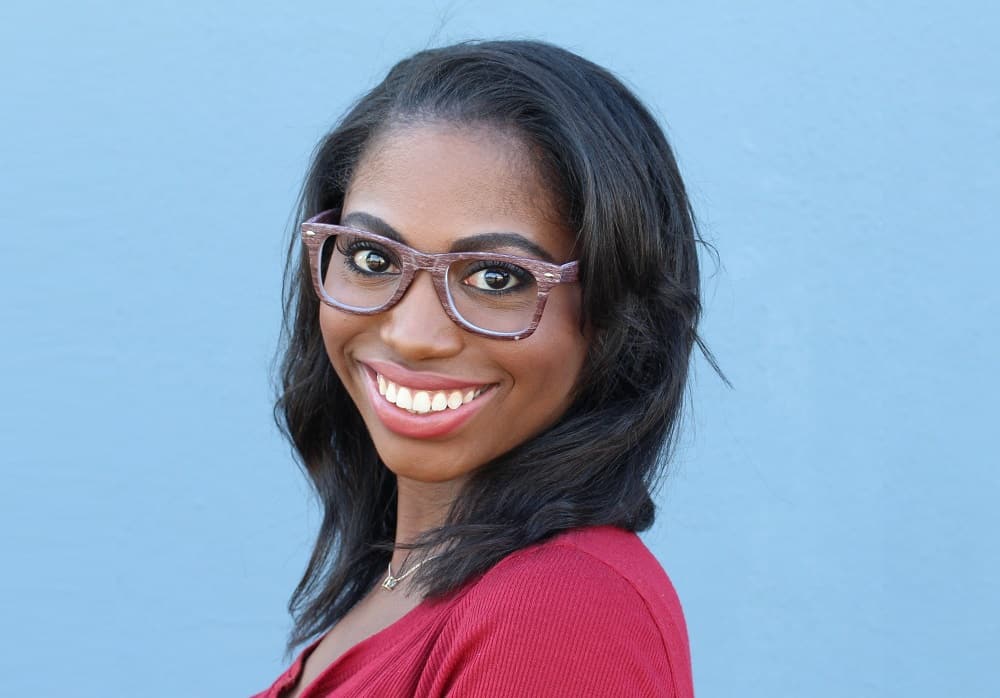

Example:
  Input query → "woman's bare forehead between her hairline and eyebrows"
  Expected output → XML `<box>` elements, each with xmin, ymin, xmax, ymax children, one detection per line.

<box><xmin>343</xmin><ymin>123</ymin><xmax>572</xmax><ymax>261</ymax></box>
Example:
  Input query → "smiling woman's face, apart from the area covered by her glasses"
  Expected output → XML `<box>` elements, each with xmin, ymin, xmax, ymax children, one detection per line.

<box><xmin>320</xmin><ymin>124</ymin><xmax>587</xmax><ymax>482</ymax></box>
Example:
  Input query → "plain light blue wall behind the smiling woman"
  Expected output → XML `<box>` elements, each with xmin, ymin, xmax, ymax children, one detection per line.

<box><xmin>0</xmin><ymin>0</ymin><xmax>1000</xmax><ymax>697</ymax></box>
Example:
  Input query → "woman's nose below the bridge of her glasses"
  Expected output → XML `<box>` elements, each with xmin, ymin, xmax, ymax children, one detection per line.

<box><xmin>379</xmin><ymin>271</ymin><xmax>464</xmax><ymax>361</ymax></box>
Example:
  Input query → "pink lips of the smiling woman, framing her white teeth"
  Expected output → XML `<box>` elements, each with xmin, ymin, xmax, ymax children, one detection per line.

<box><xmin>360</xmin><ymin>361</ymin><xmax>495</xmax><ymax>439</ymax></box>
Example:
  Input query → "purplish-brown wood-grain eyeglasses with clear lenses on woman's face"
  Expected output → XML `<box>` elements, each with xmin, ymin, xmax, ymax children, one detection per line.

<box><xmin>302</xmin><ymin>210</ymin><xmax>578</xmax><ymax>339</ymax></box>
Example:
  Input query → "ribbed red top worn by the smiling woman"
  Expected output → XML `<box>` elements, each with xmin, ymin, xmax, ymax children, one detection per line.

<box><xmin>254</xmin><ymin>527</ymin><xmax>694</xmax><ymax>698</ymax></box>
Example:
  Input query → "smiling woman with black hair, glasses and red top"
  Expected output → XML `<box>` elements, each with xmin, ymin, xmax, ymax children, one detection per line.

<box><xmin>260</xmin><ymin>42</ymin><xmax>712</xmax><ymax>698</ymax></box>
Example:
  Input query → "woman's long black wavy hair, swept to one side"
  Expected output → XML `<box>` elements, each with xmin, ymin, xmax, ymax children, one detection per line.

<box><xmin>275</xmin><ymin>41</ymin><xmax>714</xmax><ymax>648</ymax></box>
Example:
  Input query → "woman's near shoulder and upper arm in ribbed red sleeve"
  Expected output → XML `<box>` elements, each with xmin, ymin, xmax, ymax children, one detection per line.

<box><xmin>426</xmin><ymin>527</ymin><xmax>691</xmax><ymax>696</ymax></box>
